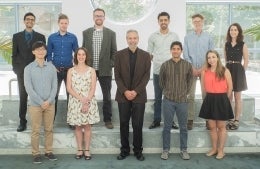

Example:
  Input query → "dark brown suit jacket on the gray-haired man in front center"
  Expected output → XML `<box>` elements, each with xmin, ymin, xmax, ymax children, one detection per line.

<box><xmin>114</xmin><ymin>48</ymin><xmax>151</xmax><ymax>103</ymax></box>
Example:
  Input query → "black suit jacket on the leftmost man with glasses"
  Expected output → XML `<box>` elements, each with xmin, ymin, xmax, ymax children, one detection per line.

<box><xmin>12</xmin><ymin>31</ymin><xmax>46</xmax><ymax>74</ymax></box>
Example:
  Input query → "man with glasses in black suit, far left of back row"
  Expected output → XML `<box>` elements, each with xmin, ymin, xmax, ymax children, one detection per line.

<box><xmin>12</xmin><ymin>12</ymin><xmax>46</xmax><ymax>132</ymax></box>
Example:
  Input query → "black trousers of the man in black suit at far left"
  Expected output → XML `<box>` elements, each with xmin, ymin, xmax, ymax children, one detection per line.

<box><xmin>17</xmin><ymin>73</ymin><xmax>28</xmax><ymax>125</ymax></box>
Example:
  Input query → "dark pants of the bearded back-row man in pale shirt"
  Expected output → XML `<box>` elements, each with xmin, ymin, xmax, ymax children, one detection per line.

<box><xmin>153</xmin><ymin>74</ymin><xmax>162</xmax><ymax>122</ymax></box>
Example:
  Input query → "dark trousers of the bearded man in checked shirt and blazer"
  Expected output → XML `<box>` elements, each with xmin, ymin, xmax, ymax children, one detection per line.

<box><xmin>96</xmin><ymin>71</ymin><xmax>112</xmax><ymax>122</ymax></box>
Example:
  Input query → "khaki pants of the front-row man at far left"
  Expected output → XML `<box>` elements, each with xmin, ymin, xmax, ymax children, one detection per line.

<box><xmin>29</xmin><ymin>105</ymin><xmax>55</xmax><ymax>156</ymax></box>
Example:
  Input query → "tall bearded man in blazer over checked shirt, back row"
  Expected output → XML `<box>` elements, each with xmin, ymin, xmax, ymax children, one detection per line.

<box><xmin>82</xmin><ymin>8</ymin><xmax>117</xmax><ymax>129</ymax></box>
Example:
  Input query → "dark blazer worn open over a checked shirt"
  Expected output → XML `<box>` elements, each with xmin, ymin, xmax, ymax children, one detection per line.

<box><xmin>82</xmin><ymin>27</ymin><xmax>117</xmax><ymax>76</ymax></box>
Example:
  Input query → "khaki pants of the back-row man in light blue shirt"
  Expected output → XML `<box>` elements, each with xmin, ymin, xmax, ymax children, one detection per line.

<box><xmin>188</xmin><ymin>76</ymin><xmax>206</xmax><ymax>120</ymax></box>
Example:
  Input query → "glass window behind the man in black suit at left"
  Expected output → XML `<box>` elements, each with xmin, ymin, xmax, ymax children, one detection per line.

<box><xmin>0</xmin><ymin>3</ymin><xmax>61</xmax><ymax>70</ymax></box>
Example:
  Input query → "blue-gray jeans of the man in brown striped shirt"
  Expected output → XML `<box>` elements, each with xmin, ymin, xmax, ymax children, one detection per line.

<box><xmin>162</xmin><ymin>98</ymin><xmax>188</xmax><ymax>151</ymax></box>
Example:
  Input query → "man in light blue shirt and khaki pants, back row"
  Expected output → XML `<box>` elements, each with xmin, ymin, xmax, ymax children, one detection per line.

<box><xmin>183</xmin><ymin>14</ymin><xmax>214</xmax><ymax>130</ymax></box>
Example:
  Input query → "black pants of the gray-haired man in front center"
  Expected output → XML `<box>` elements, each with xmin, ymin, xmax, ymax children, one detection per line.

<box><xmin>118</xmin><ymin>101</ymin><xmax>145</xmax><ymax>154</ymax></box>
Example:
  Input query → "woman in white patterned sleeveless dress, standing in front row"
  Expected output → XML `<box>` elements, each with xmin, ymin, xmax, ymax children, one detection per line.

<box><xmin>67</xmin><ymin>47</ymin><xmax>100</xmax><ymax>160</ymax></box>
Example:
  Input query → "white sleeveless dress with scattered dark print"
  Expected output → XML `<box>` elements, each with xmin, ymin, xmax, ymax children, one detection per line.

<box><xmin>67</xmin><ymin>68</ymin><xmax>100</xmax><ymax>126</ymax></box>
